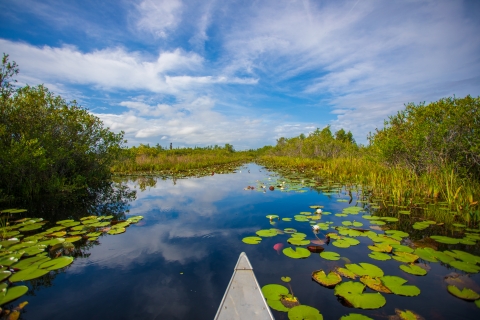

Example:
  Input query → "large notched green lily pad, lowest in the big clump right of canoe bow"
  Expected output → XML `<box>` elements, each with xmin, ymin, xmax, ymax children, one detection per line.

<box><xmin>334</xmin><ymin>281</ymin><xmax>386</xmax><ymax>309</ymax></box>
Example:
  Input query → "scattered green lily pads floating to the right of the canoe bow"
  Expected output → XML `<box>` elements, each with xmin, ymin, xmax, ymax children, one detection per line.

<box><xmin>242</xmin><ymin>200</ymin><xmax>480</xmax><ymax>319</ymax></box>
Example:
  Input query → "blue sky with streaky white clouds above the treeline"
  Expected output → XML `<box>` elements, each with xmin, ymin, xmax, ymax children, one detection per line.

<box><xmin>0</xmin><ymin>0</ymin><xmax>480</xmax><ymax>149</ymax></box>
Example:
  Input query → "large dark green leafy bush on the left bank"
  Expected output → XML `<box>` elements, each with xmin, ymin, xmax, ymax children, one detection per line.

<box><xmin>0</xmin><ymin>56</ymin><xmax>123</xmax><ymax>197</ymax></box>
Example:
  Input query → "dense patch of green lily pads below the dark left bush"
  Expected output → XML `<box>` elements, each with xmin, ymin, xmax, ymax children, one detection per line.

<box><xmin>0</xmin><ymin>209</ymin><xmax>143</xmax><ymax>307</ymax></box>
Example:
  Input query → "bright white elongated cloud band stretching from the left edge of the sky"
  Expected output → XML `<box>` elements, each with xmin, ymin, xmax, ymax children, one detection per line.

<box><xmin>0</xmin><ymin>39</ymin><xmax>257</xmax><ymax>94</ymax></box>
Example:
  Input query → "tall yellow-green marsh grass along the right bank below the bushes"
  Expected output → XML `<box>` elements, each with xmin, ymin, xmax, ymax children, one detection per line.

<box><xmin>259</xmin><ymin>155</ymin><xmax>480</xmax><ymax>226</ymax></box>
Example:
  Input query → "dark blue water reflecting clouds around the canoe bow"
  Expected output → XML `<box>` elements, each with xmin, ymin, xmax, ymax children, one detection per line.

<box><xmin>19</xmin><ymin>165</ymin><xmax>480</xmax><ymax>319</ymax></box>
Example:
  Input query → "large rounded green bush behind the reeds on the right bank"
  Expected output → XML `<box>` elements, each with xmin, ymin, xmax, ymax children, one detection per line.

<box><xmin>369</xmin><ymin>96</ymin><xmax>480</xmax><ymax>178</ymax></box>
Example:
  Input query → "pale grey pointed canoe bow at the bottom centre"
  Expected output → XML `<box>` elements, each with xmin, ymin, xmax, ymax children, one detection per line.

<box><xmin>215</xmin><ymin>252</ymin><xmax>274</xmax><ymax>320</ymax></box>
